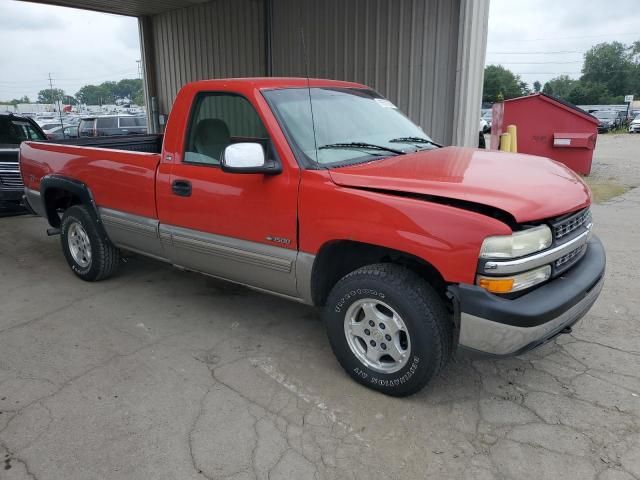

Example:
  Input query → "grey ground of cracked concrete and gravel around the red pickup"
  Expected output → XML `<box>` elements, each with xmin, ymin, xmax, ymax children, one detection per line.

<box><xmin>0</xmin><ymin>136</ymin><xmax>640</xmax><ymax>480</ymax></box>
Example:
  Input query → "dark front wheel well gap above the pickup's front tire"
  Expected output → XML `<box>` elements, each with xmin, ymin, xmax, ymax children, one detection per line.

<box><xmin>311</xmin><ymin>240</ymin><xmax>446</xmax><ymax>305</ymax></box>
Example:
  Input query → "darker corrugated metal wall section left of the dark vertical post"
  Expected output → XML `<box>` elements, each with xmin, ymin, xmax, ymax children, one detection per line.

<box><xmin>151</xmin><ymin>0</ymin><xmax>265</xmax><ymax>113</ymax></box>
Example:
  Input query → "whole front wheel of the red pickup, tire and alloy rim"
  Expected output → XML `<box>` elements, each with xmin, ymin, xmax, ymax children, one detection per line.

<box><xmin>325</xmin><ymin>264</ymin><xmax>453</xmax><ymax>396</ymax></box>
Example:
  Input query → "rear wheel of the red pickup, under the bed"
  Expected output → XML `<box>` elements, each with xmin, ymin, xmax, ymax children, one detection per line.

<box><xmin>60</xmin><ymin>205</ymin><xmax>120</xmax><ymax>282</ymax></box>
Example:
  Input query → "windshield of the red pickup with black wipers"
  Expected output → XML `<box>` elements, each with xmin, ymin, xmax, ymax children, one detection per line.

<box><xmin>264</xmin><ymin>87</ymin><xmax>435</xmax><ymax>166</ymax></box>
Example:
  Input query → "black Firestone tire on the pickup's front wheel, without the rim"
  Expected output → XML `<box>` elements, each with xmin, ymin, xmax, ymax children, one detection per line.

<box><xmin>324</xmin><ymin>263</ymin><xmax>453</xmax><ymax>397</ymax></box>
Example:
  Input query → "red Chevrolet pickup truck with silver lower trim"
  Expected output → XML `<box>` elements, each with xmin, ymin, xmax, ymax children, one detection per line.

<box><xmin>20</xmin><ymin>78</ymin><xmax>605</xmax><ymax>396</ymax></box>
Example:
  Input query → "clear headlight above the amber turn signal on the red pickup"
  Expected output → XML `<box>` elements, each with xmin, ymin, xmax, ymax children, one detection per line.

<box><xmin>480</xmin><ymin>225</ymin><xmax>552</xmax><ymax>259</ymax></box>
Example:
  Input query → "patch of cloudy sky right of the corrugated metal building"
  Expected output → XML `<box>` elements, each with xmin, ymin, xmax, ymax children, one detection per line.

<box><xmin>486</xmin><ymin>0</ymin><xmax>640</xmax><ymax>85</ymax></box>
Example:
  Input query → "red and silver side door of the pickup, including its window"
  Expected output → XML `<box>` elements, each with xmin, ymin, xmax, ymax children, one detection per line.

<box><xmin>158</xmin><ymin>92</ymin><xmax>299</xmax><ymax>296</ymax></box>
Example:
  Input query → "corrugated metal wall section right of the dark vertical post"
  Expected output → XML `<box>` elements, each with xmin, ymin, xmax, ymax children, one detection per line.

<box><xmin>272</xmin><ymin>0</ymin><xmax>460</xmax><ymax>143</ymax></box>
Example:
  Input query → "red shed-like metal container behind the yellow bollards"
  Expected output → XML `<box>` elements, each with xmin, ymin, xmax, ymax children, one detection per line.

<box><xmin>491</xmin><ymin>93</ymin><xmax>598</xmax><ymax>175</ymax></box>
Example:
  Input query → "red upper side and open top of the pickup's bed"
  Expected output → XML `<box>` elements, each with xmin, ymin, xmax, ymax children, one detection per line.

<box><xmin>20</xmin><ymin>135</ymin><xmax>162</xmax><ymax>218</ymax></box>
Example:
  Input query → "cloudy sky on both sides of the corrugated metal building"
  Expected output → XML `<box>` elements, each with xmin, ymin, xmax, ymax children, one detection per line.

<box><xmin>0</xmin><ymin>0</ymin><xmax>640</xmax><ymax>100</ymax></box>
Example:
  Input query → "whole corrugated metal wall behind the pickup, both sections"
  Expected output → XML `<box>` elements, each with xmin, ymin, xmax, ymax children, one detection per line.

<box><xmin>141</xmin><ymin>0</ymin><xmax>489</xmax><ymax>145</ymax></box>
